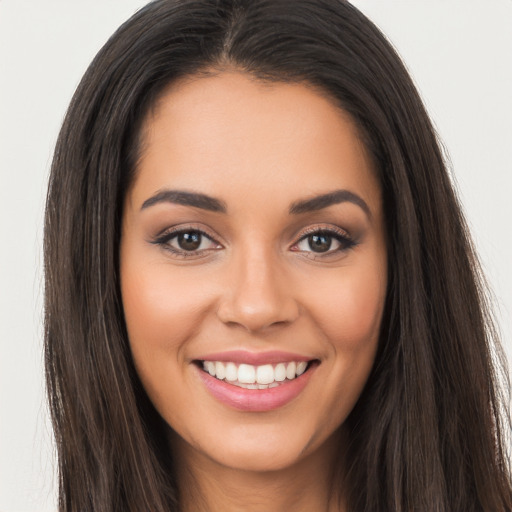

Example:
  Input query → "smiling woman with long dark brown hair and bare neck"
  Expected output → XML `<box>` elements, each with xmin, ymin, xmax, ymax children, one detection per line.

<box><xmin>45</xmin><ymin>0</ymin><xmax>512</xmax><ymax>511</ymax></box>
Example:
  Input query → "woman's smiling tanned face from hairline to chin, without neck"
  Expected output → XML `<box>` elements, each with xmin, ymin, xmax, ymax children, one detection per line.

<box><xmin>120</xmin><ymin>73</ymin><xmax>387</xmax><ymax>471</ymax></box>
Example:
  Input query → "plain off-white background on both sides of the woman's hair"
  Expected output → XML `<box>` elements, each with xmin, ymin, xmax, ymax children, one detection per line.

<box><xmin>0</xmin><ymin>0</ymin><xmax>512</xmax><ymax>512</ymax></box>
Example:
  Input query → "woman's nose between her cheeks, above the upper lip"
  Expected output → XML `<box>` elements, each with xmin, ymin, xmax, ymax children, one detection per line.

<box><xmin>217</xmin><ymin>247</ymin><xmax>300</xmax><ymax>333</ymax></box>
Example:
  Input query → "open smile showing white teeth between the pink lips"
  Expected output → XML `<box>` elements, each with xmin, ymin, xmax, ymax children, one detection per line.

<box><xmin>197</xmin><ymin>361</ymin><xmax>315</xmax><ymax>389</ymax></box>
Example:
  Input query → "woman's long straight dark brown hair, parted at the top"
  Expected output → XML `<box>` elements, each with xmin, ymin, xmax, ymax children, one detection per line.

<box><xmin>44</xmin><ymin>0</ymin><xmax>512</xmax><ymax>512</ymax></box>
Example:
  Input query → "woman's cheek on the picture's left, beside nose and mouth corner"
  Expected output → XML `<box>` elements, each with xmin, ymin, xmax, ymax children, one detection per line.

<box><xmin>121</xmin><ymin>254</ymin><xmax>215</xmax><ymax>422</ymax></box>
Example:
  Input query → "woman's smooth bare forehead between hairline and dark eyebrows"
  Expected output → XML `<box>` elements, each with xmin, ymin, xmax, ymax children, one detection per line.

<box><xmin>132</xmin><ymin>72</ymin><xmax>380</xmax><ymax>214</ymax></box>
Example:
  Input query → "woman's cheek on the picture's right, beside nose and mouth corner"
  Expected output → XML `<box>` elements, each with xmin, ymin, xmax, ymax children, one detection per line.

<box><xmin>298</xmin><ymin>269</ymin><xmax>386</xmax><ymax>431</ymax></box>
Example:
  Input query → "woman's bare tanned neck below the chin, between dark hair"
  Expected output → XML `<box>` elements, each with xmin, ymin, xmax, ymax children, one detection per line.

<box><xmin>172</xmin><ymin>428</ymin><xmax>345</xmax><ymax>512</ymax></box>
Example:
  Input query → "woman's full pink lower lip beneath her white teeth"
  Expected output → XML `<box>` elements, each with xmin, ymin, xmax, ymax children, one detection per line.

<box><xmin>196</xmin><ymin>364</ymin><xmax>317</xmax><ymax>412</ymax></box>
